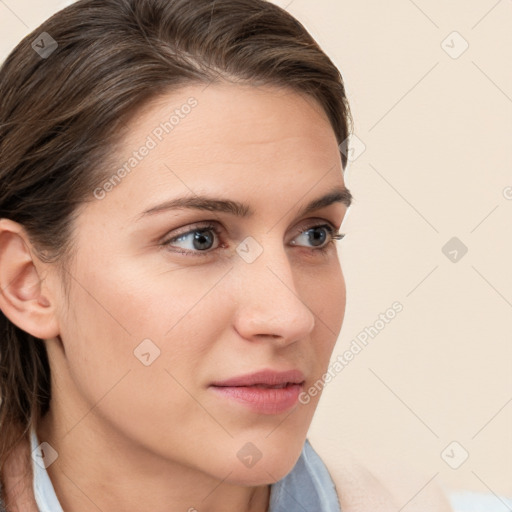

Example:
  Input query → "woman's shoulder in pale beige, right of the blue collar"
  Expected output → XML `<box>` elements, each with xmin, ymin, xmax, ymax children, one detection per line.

<box><xmin>329</xmin><ymin>452</ymin><xmax>453</xmax><ymax>512</ymax></box>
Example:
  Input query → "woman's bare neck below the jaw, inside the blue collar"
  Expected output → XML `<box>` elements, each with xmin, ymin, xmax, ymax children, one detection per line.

<box><xmin>37</xmin><ymin>410</ymin><xmax>270</xmax><ymax>512</ymax></box>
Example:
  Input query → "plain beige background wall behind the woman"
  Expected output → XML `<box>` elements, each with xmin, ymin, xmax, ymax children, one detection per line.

<box><xmin>0</xmin><ymin>0</ymin><xmax>512</xmax><ymax>504</ymax></box>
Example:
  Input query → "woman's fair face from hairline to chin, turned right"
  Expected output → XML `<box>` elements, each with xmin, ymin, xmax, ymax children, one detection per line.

<box><xmin>48</xmin><ymin>84</ymin><xmax>347</xmax><ymax>485</ymax></box>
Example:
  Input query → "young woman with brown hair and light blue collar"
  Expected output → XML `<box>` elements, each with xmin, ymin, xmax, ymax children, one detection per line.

<box><xmin>0</xmin><ymin>0</ymin><xmax>456</xmax><ymax>512</ymax></box>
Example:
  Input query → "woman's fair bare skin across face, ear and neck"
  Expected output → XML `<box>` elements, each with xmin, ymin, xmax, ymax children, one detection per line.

<box><xmin>0</xmin><ymin>84</ymin><xmax>347</xmax><ymax>512</ymax></box>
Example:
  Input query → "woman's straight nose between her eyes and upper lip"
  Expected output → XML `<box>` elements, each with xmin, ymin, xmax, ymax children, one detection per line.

<box><xmin>233</xmin><ymin>244</ymin><xmax>315</xmax><ymax>345</ymax></box>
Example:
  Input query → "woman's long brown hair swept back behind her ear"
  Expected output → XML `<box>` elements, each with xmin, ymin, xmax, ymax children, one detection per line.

<box><xmin>0</xmin><ymin>0</ymin><xmax>352</xmax><ymax>504</ymax></box>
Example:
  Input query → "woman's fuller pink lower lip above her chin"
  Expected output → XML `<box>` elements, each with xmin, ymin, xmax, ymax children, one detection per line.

<box><xmin>211</xmin><ymin>384</ymin><xmax>302</xmax><ymax>414</ymax></box>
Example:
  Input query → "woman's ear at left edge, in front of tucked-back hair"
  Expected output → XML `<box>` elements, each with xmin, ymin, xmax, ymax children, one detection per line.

<box><xmin>0</xmin><ymin>219</ymin><xmax>59</xmax><ymax>339</ymax></box>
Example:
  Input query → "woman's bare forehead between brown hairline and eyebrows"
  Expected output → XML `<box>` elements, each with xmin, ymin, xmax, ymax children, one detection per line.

<box><xmin>90</xmin><ymin>84</ymin><xmax>343</xmax><ymax>220</ymax></box>
